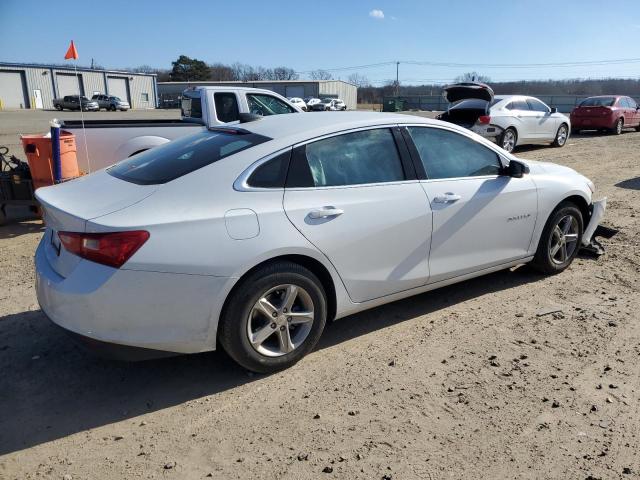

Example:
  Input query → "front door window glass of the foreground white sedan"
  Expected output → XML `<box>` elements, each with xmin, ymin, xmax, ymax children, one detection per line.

<box><xmin>408</xmin><ymin>127</ymin><xmax>502</xmax><ymax>179</ymax></box>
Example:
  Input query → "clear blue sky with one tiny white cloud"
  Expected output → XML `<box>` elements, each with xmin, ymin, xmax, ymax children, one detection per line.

<box><xmin>0</xmin><ymin>0</ymin><xmax>640</xmax><ymax>85</ymax></box>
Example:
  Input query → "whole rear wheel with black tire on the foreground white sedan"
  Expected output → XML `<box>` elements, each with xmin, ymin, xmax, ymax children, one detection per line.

<box><xmin>218</xmin><ymin>261</ymin><xmax>327</xmax><ymax>373</ymax></box>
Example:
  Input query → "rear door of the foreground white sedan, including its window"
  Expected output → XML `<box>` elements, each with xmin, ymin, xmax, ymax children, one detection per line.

<box><xmin>284</xmin><ymin>127</ymin><xmax>431</xmax><ymax>302</ymax></box>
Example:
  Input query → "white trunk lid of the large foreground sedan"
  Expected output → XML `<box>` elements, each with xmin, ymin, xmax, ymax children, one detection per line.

<box><xmin>36</xmin><ymin>170</ymin><xmax>159</xmax><ymax>277</ymax></box>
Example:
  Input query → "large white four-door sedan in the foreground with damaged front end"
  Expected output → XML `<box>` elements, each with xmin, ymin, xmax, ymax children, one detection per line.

<box><xmin>35</xmin><ymin>112</ymin><xmax>605</xmax><ymax>372</ymax></box>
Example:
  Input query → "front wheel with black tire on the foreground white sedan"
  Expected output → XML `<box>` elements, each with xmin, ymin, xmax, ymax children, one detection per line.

<box><xmin>531</xmin><ymin>202</ymin><xmax>583</xmax><ymax>275</ymax></box>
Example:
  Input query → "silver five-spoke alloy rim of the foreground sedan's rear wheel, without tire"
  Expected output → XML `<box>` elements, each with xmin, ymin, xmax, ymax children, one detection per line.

<box><xmin>247</xmin><ymin>284</ymin><xmax>315</xmax><ymax>357</ymax></box>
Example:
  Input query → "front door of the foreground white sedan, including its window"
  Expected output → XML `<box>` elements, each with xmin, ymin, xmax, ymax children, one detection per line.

<box><xmin>406</xmin><ymin>126</ymin><xmax>537</xmax><ymax>283</ymax></box>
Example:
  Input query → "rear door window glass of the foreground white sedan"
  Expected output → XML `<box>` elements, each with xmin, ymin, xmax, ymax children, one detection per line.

<box><xmin>287</xmin><ymin>128</ymin><xmax>405</xmax><ymax>187</ymax></box>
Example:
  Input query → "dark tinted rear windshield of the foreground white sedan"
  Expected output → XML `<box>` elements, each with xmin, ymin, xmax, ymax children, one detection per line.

<box><xmin>107</xmin><ymin>130</ymin><xmax>271</xmax><ymax>185</ymax></box>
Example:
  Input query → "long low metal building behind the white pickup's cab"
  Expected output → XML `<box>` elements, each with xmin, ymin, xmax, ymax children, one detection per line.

<box><xmin>158</xmin><ymin>80</ymin><xmax>358</xmax><ymax>110</ymax></box>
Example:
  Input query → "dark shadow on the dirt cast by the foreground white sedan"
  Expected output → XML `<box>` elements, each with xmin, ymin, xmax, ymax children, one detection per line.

<box><xmin>0</xmin><ymin>267</ymin><xmax>544</xmax><ymax>455</ymax></box>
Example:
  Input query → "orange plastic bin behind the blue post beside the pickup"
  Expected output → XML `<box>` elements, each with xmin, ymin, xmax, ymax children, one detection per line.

<box><xmin>20</xmin><ymin>131</ymin><xmax>80</xmax><ymax>190</ymax></box>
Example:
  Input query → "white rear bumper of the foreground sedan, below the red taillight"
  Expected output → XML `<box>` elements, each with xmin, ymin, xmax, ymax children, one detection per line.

<box><xmin>35</xmin><ymin>242</ymin><xmax>231</xmax><ymax>353</ymax></box>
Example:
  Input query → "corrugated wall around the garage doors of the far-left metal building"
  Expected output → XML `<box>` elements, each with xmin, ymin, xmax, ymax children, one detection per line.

<box><xmin>0</xmin><ymin>65</ymin><xmax>156</xmax><ymax>109</ymax></box>
